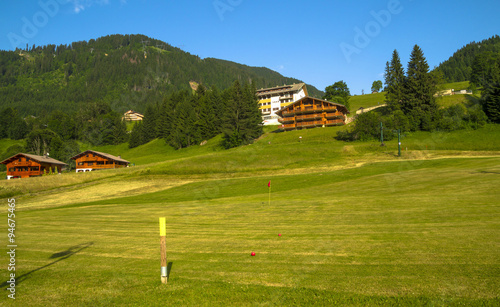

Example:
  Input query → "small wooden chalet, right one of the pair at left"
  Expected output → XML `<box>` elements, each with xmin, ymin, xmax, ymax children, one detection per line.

<box><xmin>71</xmin><ymin>150</ymin><xmax>130</xmax><ymax>173</ymax></box>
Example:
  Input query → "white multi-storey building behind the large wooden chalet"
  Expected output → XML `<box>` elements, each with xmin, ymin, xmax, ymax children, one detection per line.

<box><xmin>257</xmin><ymin>83</ymin><xmax>307</xmax><ymax>125</ymax></box>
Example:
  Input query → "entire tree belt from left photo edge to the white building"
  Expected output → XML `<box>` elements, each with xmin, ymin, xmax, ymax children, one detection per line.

<box><xmin>0</xmin><ymin>81</ymin><xmax>262</xmax><ymax>172</ymax></box>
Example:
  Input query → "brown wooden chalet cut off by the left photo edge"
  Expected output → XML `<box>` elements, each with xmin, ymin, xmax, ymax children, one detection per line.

<box><xmin>0</xmin><ymin>153</ymin><xmax>67</xmax><ymax>179</ymax></box>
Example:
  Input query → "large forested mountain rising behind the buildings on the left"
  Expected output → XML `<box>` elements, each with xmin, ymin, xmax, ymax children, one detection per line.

<box><xmin>0</xmin><ymin>35</ymin><xmax>323</xmax><ymax>116</ymax></box>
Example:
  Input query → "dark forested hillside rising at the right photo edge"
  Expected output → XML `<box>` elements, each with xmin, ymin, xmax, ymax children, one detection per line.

<box><xmin>438</xmin><ymin>35</ymin><xmax>500</xmax><ymax>82</ymax></box>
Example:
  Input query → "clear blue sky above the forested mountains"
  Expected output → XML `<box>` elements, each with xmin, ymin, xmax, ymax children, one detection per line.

<box><xmin>0</xmin><ymin>0</ymin><xmax>500</xmax><ymax>95</ymax></box>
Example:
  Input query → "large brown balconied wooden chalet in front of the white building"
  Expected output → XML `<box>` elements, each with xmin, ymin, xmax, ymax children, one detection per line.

<box><xmin>276</xmin><ymin>96</ymin><xmax>349</xmax><ymax>131</ymax></box>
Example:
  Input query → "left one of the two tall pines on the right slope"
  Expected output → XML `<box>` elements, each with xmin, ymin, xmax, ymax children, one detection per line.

<box><xmin>385</xmin><ymin>50</ymin><xmax>405</xmax><ymax>111</ymax></box>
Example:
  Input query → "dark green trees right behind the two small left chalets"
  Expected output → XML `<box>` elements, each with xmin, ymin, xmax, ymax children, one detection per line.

<box><xmin>0</xmin><ymin>102</ymin><xmax>129</xmax><ymax>172</ymax></box>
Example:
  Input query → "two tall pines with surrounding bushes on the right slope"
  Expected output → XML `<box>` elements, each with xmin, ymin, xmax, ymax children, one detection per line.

<box><xmin>337</xmin><ymin>45</ymin><xmax>494</xmax><ymax>141</ymax></box>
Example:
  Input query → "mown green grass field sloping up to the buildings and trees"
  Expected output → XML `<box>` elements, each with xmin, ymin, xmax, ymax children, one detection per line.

<box><xmin>0</xmin><ymin>125</ymin><xmax>500</xmax><ymax>306</ymax></box>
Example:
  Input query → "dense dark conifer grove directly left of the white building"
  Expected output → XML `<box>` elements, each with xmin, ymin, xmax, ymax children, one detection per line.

<box><xmin>129</xmin><ymin>81</ymin><xmax>262</xmax><ymax>149</ymax></box>
